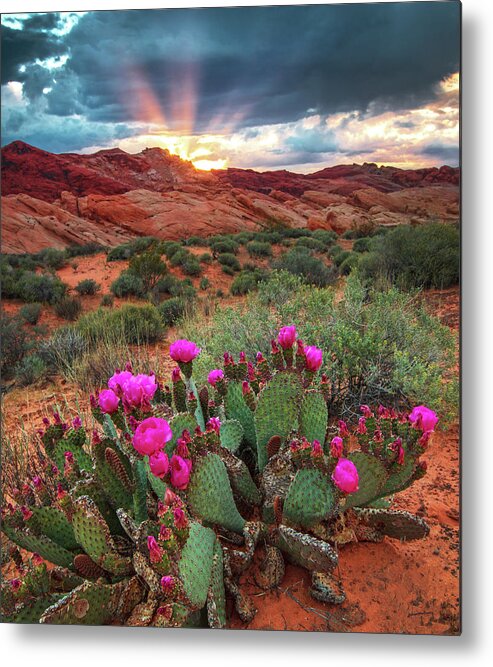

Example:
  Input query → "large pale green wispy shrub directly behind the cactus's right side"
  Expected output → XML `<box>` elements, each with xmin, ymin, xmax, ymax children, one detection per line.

<box><xmin>178</xmin><ymin>273</ymin><xmax>458</xmax><ymax>417</ymax></box>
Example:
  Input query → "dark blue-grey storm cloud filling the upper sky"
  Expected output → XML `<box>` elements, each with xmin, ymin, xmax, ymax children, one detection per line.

<box><xmin>2</xmin><ymin>2</ymin><xmax>460</xmax><ymax>152</ymax></box>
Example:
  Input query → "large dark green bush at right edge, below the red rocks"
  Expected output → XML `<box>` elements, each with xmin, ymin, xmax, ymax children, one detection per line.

<box><xmin>358</xmin><ymin>223</ymin><xmax>460</xmax><ymax>289</ymax></box>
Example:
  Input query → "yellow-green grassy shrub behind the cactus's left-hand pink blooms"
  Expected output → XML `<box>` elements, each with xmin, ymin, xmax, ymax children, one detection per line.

<box><xmin>75</xmin><ymin>304</ymin><xmax>164</xmax><ymax>345</ymax></box>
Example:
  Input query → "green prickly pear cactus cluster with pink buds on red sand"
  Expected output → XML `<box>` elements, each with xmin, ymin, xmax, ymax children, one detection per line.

<box><xmin>2</xmin><ymin>332</ymin><xmax>429</xmax><ymax>628</ymax></box>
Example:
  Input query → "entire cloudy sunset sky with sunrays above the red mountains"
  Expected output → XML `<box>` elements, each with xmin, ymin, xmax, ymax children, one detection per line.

<box><xmin>1</xmin><ymin>0</ymin><xmax>460</xmax><ymax>173</ymax></box>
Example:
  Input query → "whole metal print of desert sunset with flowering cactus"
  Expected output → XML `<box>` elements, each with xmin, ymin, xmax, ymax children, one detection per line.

<box><xmin>1</xmin><ymin>2</ymin><xmax>460</xmax><ymax>635</ymax></box>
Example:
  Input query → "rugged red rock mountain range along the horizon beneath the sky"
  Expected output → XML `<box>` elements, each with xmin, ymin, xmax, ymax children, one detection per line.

<box><xmin>1</xmin><ymin>141</ymin><xmax>459</xmax><ymax>252</ymax></box>
